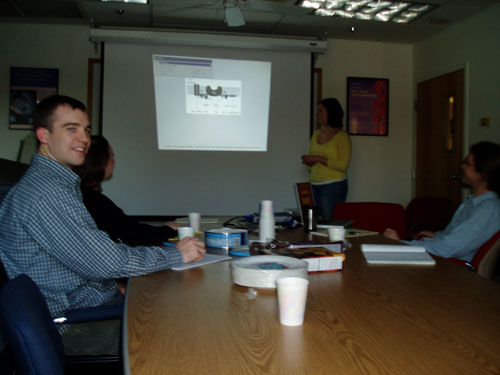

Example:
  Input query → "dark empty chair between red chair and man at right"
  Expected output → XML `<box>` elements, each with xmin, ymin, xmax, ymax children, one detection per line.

<box><xmin>405</xmin><ymin>197</ymin><xmax>451</xmax><ymax>239</ymax></box>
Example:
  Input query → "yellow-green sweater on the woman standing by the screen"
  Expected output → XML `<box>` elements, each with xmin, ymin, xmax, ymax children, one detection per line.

<box><xmin>309</xmin><ymin>130</ymin><xmax>351</xmax><ymax>183</ymax></box>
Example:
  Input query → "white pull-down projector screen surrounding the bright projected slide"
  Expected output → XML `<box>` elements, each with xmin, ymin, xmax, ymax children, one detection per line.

<box><xmin>102</xmin><ymin>43</ymin><xmax>311</xmax><ymax>216</ymax></box>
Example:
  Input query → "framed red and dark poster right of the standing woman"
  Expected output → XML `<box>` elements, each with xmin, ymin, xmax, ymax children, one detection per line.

<box><xmin>347</xmin><ymin>77</ymin><xmax>389</xmax><ymax>136</ymax></box>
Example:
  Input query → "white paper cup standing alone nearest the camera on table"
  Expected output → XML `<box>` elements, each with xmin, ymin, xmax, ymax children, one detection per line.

<box><xmin>276</xmin><ymin>277</ymin><xmax>309</xmax><ymax>326</ymax></box>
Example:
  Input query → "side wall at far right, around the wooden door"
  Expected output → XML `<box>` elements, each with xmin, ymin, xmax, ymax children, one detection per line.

<box><xmin>414</xmin><ymin>4</ymin><xmax>500</xmax><ymax>150</ymax></box>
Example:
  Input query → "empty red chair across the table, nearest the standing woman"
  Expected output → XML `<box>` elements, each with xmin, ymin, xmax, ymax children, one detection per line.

<box><xmin>333</xmin><ymin>202</ymin><xmax>406</xmax><ymax>238</ymax></box>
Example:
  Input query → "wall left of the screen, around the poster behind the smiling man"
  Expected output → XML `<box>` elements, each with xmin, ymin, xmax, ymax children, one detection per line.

<box><xmin>0</xmin><ymin>23</ymin><xmax>99</xmax><ymax>160</ymax></box>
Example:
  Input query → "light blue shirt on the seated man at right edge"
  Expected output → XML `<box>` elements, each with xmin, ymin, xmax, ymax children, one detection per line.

<box><xmin>404</xmin><ymin>191</ymin><xmax>500</xmax><ymax>262</ymax></box>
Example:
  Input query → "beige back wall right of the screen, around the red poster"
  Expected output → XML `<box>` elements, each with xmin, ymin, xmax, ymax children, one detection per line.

<box><xmin>315</xmin><ymin>39</ymin><xmax>414</xmax><ymax>206</ymax></box>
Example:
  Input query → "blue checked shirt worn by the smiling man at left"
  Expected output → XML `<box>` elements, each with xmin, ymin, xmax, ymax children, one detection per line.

<box><xmin>0</xmin><ymin>154</ymin><xmax>183</xmax><ymax>316</ymax></box>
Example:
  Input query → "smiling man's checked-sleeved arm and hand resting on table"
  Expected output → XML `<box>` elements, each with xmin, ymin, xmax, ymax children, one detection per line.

<box><xmin>27</xmin><ymin>189</ymin><xmax>204</xmax><ymax>280</ymax></box>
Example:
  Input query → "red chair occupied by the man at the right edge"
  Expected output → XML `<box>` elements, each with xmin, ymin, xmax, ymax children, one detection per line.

<box><xmin>448</xmin><ymin>231</ymin><xmax>500</xmax><ymax>280</ymax></box>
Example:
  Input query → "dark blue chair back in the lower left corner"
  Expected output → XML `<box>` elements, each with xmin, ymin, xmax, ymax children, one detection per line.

<box><xmin>0</xmin><ymin>275</ymin><xmax>65</xmax><ymax>375</ymax></box>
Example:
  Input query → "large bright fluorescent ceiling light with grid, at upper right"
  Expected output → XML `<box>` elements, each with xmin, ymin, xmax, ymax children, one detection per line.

<box><xmin>300</xmin><ymin>0</ymin><xmax>435</xmax><ymax>23</ymax></box>
